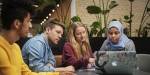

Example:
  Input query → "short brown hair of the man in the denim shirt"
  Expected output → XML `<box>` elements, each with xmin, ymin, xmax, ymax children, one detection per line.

<box><xmin>42</xmin><ymin>18</ymin><xmax>65</xmax><ymax>31</ymax></box>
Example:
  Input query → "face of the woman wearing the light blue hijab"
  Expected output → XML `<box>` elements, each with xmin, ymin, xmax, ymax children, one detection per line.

<box><xmin>108</xmin><ymin>27</ymin><xmax>121</xmax><ymax>44</ymax></box>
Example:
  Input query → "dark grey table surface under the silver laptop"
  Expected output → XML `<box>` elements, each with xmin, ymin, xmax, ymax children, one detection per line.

<box><xmin>76</xmin><ymin>69</ymin><xmax>150</xmax><ymax>75</ymax></box>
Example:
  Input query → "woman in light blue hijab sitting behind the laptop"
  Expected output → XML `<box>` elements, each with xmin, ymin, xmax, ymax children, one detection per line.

<box><xmin>100</xmin><ymin>21</ymin><xmax>135</xmax><ymax>51</ymax></box>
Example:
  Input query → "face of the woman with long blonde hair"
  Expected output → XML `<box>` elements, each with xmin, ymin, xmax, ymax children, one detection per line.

<box><xmin>74</xmin><ymin>26</ymin><xmax>87</xmax><ymax>42</ymax></box>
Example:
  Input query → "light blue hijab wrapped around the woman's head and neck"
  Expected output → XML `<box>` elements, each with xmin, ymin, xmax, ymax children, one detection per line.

<box><xmin>107</xmin><ymin>21</ymin><xmax>129</xmax><ymax>51</ymax></box>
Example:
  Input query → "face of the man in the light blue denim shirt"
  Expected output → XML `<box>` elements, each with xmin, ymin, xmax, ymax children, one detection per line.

<box><xmin>46</xmin><ymin>25</ymin><xmax>63</xmax><ymax>44</ymax></box>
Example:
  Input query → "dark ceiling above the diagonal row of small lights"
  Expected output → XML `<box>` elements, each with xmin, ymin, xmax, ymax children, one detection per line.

<box><xmin>0</xmin><ymin>0</ymin><xmax>60</xmax><ymax>24</ymax></box>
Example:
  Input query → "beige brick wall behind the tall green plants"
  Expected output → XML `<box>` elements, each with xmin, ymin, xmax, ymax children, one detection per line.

<box><xmin>76</xmin><ymin>0</ymin><xmax>150</xmax><ymax>36</ymax></box>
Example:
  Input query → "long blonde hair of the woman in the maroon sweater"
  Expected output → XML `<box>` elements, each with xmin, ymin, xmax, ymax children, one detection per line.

<box><xmin>67</xmin><ymin>22</ymin><xmax>91</xmax><ymax>59</ymax></box>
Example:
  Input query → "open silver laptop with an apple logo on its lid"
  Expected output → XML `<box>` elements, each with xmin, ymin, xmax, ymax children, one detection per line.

<box><xmin>95</xmin><ymin>51</ymin><xmax>136</xmax><ymax>75</ymax></box>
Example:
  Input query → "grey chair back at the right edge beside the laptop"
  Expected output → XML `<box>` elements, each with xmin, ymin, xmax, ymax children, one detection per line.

<box><xmin>136</xmin><ymin>54</ymin><xmax>150</xmax><ymax>72</ymax></box>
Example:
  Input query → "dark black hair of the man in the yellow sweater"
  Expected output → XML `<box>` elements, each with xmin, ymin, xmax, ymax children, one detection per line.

<box><xmin>1</xmin><ymin>0</ymin><xmax>33</xmax><ymax>30</ymax></box>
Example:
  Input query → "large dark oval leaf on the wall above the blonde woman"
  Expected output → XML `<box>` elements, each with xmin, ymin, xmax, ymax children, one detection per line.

<box><xmin>86</xmin><ymin>5</ymin><xmax>101</xmax><ymax>14</ymax></box>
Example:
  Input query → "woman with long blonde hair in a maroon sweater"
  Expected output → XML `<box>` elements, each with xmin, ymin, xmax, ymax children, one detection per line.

<box><xmin>62</xmin><ymin>22</ymin><xmax>95</xmax><ymax>69</ymax></box>
